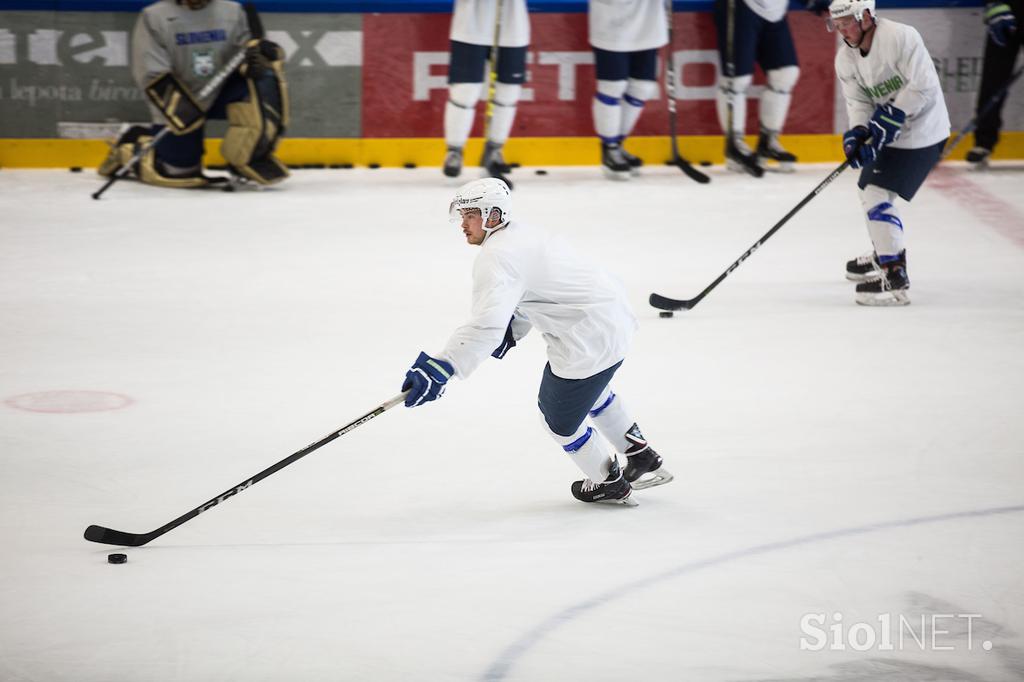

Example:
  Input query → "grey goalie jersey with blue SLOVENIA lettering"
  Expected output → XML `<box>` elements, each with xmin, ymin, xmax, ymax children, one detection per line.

<box><xmin>131</xmin><ymin>0</ymin><xmax>249</xmax><ymax>121</ymax></box>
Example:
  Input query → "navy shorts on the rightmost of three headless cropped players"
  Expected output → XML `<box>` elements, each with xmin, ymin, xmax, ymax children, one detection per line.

<box><xmin>714</xmin><ymin>0</ymin><xmax>799</xmax><ymax>76</ymax></box>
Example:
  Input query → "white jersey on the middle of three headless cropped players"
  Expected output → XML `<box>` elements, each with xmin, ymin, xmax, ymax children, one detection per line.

<box><xmin>587</xmin><ymin>0</ymin><xmax>669</xmax><ymax>52</ymax></box>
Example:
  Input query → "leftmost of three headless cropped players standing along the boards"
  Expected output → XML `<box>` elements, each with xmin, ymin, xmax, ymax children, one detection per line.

<box><xmin>443</xmin><ymin>0</ymin><xmax>529</xmax><ymax>177</ymax></box>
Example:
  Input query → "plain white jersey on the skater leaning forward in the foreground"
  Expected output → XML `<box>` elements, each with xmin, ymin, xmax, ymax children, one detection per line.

<box><xmin>440</xmin><ymin>221</ymin><xmax>637</xmax><ymax>379</ymax></box>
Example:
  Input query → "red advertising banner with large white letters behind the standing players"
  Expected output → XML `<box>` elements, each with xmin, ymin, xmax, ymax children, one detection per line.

<box><xmin>362</xmin><ymin>11</ymin><xmax>836</xmax><ymax>137</ymax></box>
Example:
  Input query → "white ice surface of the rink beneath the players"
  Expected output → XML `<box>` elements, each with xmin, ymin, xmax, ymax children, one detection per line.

<box><xmin>0</xmin><ymin>166</ymin><xmax>1024</xmax><ymax>682</ymax></box>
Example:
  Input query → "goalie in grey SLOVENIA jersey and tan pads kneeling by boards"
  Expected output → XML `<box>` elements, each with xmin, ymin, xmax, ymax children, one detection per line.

<box><xmin>98</xmin><ymin>0</ymin><xmax>289</xmax><ymax>187</ymax></box>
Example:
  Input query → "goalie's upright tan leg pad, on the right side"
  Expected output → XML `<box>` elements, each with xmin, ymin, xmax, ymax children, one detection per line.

<box><xmin>220</xmin><ymin>66</ymin><xmax>289</xmax><ymax>184</ymax></box>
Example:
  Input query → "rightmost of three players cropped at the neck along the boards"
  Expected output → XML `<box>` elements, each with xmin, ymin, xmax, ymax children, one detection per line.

<box><xmin>714</xmin><ymin>0</ymin><xmax>800</xmax><ymax>177</ymax></box>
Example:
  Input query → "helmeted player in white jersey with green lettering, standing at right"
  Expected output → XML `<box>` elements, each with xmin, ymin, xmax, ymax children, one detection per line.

<box><xmin>827</xmin><ymin>0</ymin><xmax>949</xmax><ymax>305</ymax></box>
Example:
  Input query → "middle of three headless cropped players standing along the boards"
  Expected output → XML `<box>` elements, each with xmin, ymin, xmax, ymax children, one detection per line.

<box><xmin>588</xmin><ymin>0</ymin><xmax>669</xmax><ymax>180</ymax></box>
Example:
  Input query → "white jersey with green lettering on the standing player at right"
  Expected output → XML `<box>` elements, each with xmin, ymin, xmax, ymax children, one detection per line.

<box><xmin>836</xmin><ymin>18</ymin><xmax>949</xmax><ymax>150</ymax></box>
